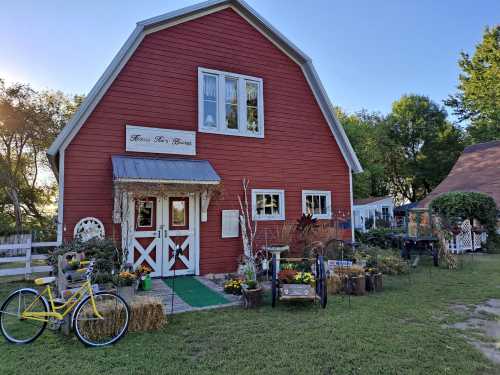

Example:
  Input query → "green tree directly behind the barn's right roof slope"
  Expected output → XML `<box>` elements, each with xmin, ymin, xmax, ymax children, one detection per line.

<box><xmin>336</xmin><ymin>108</ymin><xmax>389</xmax><ymax>198</ymax></box>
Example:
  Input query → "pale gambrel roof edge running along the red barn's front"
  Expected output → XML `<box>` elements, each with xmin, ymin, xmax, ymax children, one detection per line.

<box><xmin>47</xmin><ymin>0</ymin><xmax>363</xmax><ymax>174</ymax></box>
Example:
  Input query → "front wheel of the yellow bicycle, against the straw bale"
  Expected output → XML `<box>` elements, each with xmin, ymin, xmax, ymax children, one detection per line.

<box><xmin>73</xmin><ymin>292</ymin><xmax>130</xmax><ymax>346</ymax></box>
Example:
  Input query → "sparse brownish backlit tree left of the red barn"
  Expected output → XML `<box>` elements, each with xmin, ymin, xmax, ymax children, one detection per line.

<box><xmin>0</xmin><ymin>79</ymin><xmax>82</xmax><ymax>231</ymax></box>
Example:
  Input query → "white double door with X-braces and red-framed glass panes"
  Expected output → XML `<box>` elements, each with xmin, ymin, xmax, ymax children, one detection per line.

<box><xmin>129</xmin><ymin>193</ymin><xmax>199</xmax><ymax>277</ymax></box>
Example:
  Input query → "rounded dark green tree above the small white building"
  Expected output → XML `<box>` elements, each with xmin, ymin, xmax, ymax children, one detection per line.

<box><xmin>379</xmin><ymin>95</ymin><xmax>464</xmax><ymax>202</ymax></box>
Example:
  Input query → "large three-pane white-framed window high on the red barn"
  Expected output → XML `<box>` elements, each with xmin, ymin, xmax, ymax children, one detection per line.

<box><xmin>198</xmin><ymin>68</ymin><xmax>264</xmax><ymax>138</ymax></box>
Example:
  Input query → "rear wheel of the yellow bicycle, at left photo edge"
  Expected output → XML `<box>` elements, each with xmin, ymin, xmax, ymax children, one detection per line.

<box><xmin>0</xmin><ymin>289</ymin><xmax>49</xmax><ymax>344</ymax></box>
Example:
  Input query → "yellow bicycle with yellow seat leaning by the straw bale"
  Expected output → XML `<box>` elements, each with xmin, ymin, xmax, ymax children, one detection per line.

<box><xmin>0</xmin><ymin>262</ymin><xmax>130</xmax><ymax>347</ymax></box>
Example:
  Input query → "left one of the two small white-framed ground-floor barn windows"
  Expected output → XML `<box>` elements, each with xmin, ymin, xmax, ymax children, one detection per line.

<box><xmin>252</xmin><ymin>189</ymin><xmax>285</xmax><ymax>220</ymax></box>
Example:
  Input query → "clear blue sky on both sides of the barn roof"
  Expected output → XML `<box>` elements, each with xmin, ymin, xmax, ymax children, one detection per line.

<box><xmin>0</xmin><ymin>0</ymin><xmax>500</xmax><ymax>113</ymax></box>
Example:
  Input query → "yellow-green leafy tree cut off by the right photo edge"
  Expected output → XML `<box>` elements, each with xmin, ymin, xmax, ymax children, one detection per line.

<box><xmin>445</xmin><ymin>26</ymin><xmax>500</xmax><ymax>143</ymax></box>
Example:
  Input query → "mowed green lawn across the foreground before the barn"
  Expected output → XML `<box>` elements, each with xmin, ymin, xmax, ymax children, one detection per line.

<box><xmin>0</xmin><ymin>255</ymin><xmax>500</xmax><ymax>375</ymax></box>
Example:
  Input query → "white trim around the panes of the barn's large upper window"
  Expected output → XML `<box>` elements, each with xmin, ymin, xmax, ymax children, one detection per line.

<box><xmin>198</xmin><ymin>67</ymin><xmax>264</xmax><ymax>138</ymax></box>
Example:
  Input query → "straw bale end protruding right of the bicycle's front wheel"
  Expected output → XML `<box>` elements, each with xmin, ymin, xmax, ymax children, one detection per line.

<box><xmin>128</xmin><ymin>296</ymin><xmax>167</xmax><ymax>332</ymax></box>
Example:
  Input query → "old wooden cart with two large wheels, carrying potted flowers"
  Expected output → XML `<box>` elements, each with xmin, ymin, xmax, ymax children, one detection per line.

<box><xmin>271</xmin><ymin>255</ymin><xmax>327</xmax><ymax>308</ymax></box>
